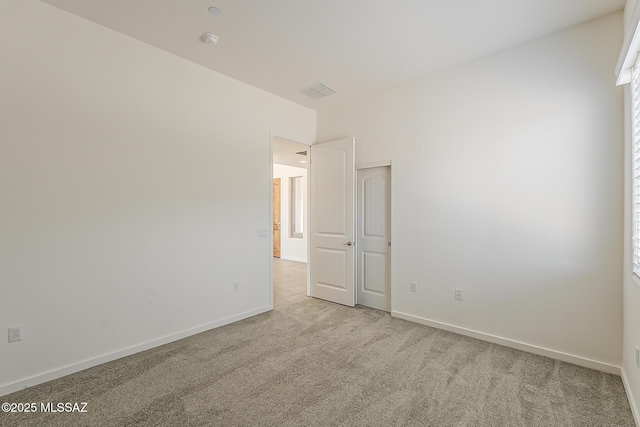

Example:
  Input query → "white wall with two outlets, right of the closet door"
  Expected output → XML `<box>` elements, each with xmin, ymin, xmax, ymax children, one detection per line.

<box><xmin>317</xmin><ymin>13</ymin><xmax>623</xmax><ymax>372</ymax></box>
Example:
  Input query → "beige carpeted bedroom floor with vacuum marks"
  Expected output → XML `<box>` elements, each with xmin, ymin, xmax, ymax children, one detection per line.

<box><xmin>0</xmin><ymin>298</ymin><xmax>635</xmax><ymax>427</ymax></box>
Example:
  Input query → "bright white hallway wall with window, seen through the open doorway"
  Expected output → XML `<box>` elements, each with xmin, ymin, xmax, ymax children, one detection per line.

<box><xmin>273</xmin><ymin>164</ymin><xmax>308</xmax><ymax>262</ymax></box>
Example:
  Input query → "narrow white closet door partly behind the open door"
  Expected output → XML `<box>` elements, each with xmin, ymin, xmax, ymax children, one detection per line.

<box><xmin>356</xmin><ymin>166</ymin><xmax>391</xmax><ymax>311</ymax></box>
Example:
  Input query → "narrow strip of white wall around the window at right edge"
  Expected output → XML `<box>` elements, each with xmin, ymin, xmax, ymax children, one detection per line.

<box><xmin>622</xmin><ymin>0</ymin><xmax>640</xmax><ymax>423</ymax></box>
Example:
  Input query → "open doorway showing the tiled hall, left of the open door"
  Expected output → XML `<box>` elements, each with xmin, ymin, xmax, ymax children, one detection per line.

<box><xmin>271</xmin><ymin>136</ymin><xmax>309</xmax><ymax>308</ymax></box>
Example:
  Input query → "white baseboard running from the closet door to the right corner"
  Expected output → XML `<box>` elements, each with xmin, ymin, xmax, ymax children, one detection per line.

<box><xmin>391</xmin><ymin>311</ymin><xmax>621</xmax><ymax>376</ymax></box>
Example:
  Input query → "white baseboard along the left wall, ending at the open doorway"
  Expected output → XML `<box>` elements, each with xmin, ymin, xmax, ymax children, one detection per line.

<box><xmin>0</xmin><ymin>306</ymin><xmax>272</xmax><ymax>396</ymax></box>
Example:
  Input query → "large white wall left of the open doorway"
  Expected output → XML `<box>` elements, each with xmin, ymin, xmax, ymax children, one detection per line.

<box><xmin>0</xmin><ymin>0</ymin><xmax>315</xmax><ymax>394</ymax></box>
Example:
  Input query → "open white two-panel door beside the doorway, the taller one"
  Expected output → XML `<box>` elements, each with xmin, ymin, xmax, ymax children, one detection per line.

<box><xmin>309</xmin><ymin>138</ymin><xmax>356</xmax><ymax>307</ymax></box>
